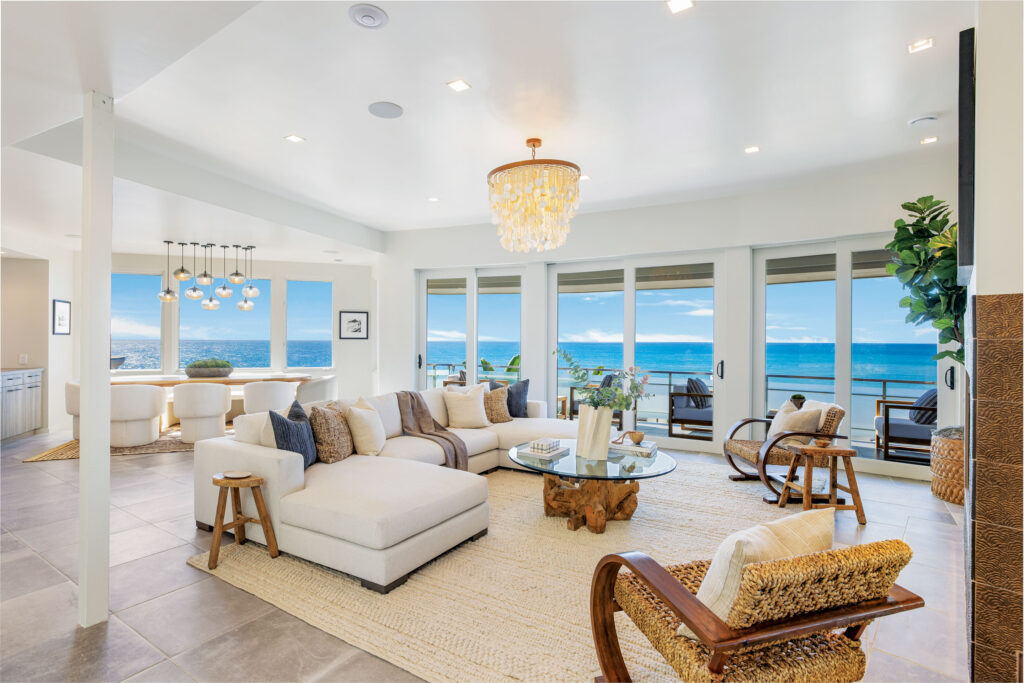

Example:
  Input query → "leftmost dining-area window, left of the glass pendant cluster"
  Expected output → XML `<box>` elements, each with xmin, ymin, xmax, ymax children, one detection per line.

<box><xmin>111</xmin><ymin>272</ymin><xmax>164</xmax><ymax>370</ymax></box>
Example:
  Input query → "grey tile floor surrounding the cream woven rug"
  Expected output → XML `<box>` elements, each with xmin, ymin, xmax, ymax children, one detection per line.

<box><xmin>0</xmin><ymin>433</ymin><xmax>967</xmax><ymax>682</ymax></box>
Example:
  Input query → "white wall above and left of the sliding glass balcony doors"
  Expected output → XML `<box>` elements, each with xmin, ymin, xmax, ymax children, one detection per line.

<box><xmin>378</xmin><ymin>148</ymin><xmax>956</xmax><ymax>398</ymax></box>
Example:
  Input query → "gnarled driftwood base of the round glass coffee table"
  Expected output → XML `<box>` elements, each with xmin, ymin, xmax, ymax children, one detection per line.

<box><xmin>544</xmin><ymin>474</ymin><xmax>640</xmax><ymax>533</ymax></box>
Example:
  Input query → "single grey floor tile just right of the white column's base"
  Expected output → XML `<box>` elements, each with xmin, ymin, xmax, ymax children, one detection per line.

<box><xmin>118</xmin><ymin>580</ymin><xmax>273</xmax><ymax>656</ymax></box>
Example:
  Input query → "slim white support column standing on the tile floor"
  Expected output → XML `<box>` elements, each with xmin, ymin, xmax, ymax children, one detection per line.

<box><xmin>76</xmin><ymin>92</ymin><xmax>114</xmax><ymax>627</ymax></box>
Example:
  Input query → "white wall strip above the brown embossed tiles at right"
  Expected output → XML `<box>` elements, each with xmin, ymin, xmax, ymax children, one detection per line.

<box><xmin>975</xmin><ymin>0</ymin><xmax>1024</xmax><ymax>294</ymax></box>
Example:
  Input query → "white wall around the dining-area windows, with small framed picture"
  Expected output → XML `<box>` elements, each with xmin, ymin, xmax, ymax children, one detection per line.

<box><xmin>113</xmin><ymin>250</ymin><xmax>377</xmax><ymax>396</ymax></box>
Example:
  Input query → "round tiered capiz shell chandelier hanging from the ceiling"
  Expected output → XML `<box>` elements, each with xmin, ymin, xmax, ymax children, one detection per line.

<box><xmin>487</xmin><ymin>137</ymin><xmax>580</xmax><ymax>252</ymax></box>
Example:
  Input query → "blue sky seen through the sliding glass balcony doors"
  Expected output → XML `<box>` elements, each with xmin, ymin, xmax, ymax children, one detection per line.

<box><xmin>427</xmin><ymin>278</ymin><xmax>936</xmax><ymax>344</ymax></box>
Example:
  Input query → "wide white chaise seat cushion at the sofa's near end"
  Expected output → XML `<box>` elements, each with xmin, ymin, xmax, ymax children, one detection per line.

<box><xmin>281</xmin><ymin>456</ymin><xmax>487</xmax><ymax>550</ymax></box>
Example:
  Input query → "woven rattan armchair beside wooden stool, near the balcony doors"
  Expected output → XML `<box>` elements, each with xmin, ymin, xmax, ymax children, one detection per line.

<box><xmin>722</xmin><ymin>405</ymin><xmax>847</xmax><ymax>505</ymax></box>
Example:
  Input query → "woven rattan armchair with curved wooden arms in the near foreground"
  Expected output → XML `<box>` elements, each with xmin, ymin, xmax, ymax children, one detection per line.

<box><xmin>590</xmin><ymin>541</ymin><xmax>925</xmax><ymax>683</ymax></box>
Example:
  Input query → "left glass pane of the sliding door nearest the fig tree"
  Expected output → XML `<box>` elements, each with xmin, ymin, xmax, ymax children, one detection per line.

<box><xmin>765</xmin><ymin>254</ymin><xmax>836</xmax><ymax>410</ymax></box>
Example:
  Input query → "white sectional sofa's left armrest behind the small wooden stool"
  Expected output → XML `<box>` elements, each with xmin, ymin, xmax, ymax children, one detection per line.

<box><xmin>193</xmin><ymin>436</ymin><xmax>305</xmax><ymax>529</ymax></box>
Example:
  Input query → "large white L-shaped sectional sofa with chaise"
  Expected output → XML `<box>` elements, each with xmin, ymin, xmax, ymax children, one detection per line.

<box><xmin>195</xmin><ymin>389</ymin><xmax>598</xmax><ymax>593</ymax></box>
